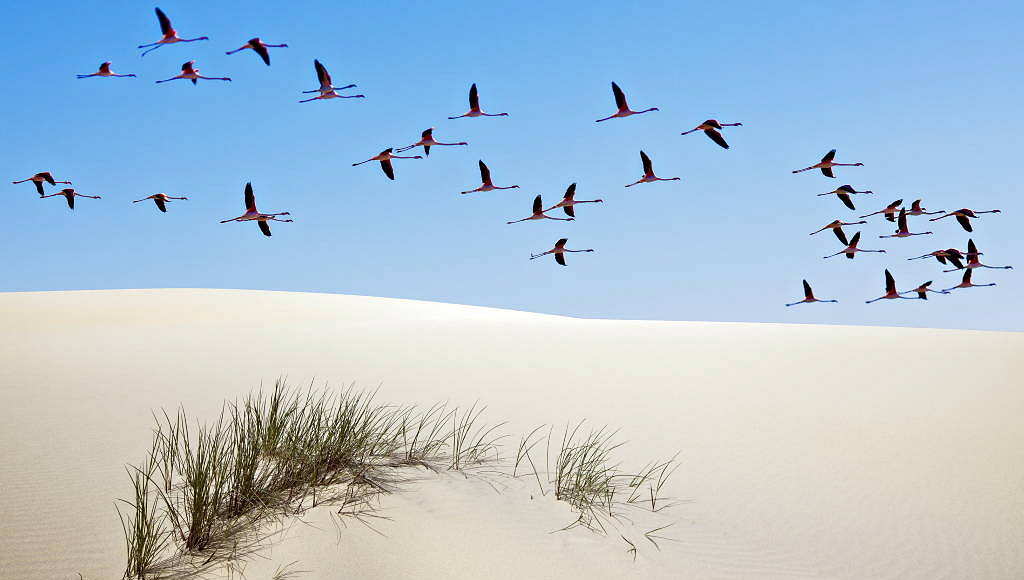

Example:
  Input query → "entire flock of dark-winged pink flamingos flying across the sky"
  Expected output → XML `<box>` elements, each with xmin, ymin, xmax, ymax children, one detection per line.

<box><xmin>12</xmin><ymin>7</ymin><xmax>1013</xmax><ymax>306</ymax></box>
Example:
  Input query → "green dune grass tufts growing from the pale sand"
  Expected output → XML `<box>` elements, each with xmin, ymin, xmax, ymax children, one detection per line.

<box><xmin>118</xmin><ymin>380</ymin><xmax>674</xmax><ymax>580</ymax></box>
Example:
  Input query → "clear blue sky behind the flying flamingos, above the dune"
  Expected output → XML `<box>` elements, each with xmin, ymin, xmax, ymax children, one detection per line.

<box><xmin>0</xmin><ymin>0</ymin><xmax>1024</xmax><ymax>330</ymax></box>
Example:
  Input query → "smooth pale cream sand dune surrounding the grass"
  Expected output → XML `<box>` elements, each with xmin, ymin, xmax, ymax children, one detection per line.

<box><xmin>0</xmin><ymin>290</ymin><xmax>1024</xmax><ymax>580</ymax></box>
